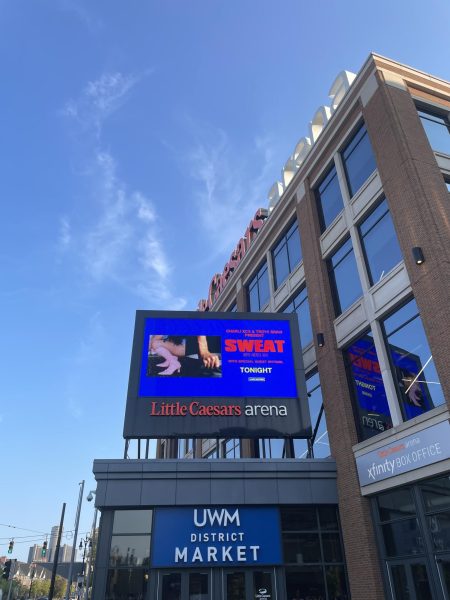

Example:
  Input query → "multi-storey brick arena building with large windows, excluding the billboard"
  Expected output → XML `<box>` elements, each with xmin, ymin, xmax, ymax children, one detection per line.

<box><xmin>94</xmin><ymin>54</ymin><xmax>450</xmax><ymax>600</ymax></box>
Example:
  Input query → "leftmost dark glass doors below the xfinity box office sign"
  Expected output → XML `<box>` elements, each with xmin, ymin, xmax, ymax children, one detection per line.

<box><xmin>388</xmin><ymin>560</ymin><xmax>433</xmax><ymax>600</ymax></box>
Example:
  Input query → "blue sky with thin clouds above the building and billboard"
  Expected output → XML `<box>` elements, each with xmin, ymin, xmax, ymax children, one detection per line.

<box><xmin>0</xmin><ymin>0</ymin><xmax>450</xmax><ymax>559</ymax></box>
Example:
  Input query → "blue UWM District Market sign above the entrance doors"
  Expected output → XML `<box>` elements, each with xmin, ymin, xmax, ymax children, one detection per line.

<box><xmin>151</xmin><ymin>506</ymin><xmax>283</xmax><ymax>567</ymax></box>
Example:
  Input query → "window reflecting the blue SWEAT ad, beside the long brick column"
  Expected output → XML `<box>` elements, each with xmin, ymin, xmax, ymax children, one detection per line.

<box><xmin>344</xmin><ymin>332</ymin><xmax>392</xmax><ymax>440</ymax></box>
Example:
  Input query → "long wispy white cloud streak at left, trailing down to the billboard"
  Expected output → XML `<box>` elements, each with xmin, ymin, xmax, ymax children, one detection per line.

<box><xmin>59</xmin><ymin>72</ymin><xmax>185</xmax><ymax>308</ymax></box>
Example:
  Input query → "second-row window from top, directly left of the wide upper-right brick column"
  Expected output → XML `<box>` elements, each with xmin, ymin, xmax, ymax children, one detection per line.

<box><xmin>359</xmin><ymin>199</ymin><xmax>402</xmax><ymax>285</ymax></box>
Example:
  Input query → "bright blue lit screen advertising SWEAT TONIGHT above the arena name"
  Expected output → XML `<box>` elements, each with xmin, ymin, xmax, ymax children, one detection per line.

<box><xmin>139</xmin><ymin>317</ymin><xmax>297</xmax><ymax>398</ymax></box>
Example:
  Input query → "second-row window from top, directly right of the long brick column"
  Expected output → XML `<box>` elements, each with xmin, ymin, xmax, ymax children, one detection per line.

<box><xmin>328</xmin><ymin>238</ymin><xmax>362</xmax><ymax>315</ymax></box>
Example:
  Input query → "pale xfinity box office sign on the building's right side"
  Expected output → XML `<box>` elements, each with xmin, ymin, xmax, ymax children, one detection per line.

<box><xmin>356</xmin><ymin>421</ymin><xmax>450</xmax><ymax>486</ymax></box>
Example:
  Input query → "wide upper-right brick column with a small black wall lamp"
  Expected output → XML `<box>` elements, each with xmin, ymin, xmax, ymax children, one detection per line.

<box><xmin>363</xmin><ymin>73</ymin><xmax>450</xmax><ymax>405</ymax></box>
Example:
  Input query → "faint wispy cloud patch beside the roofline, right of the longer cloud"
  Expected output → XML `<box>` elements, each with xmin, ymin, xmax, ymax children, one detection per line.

<box><xmin>187</xmin><ymin>122</ymin><xmax>273</xmax><ymax>256</ymax></box>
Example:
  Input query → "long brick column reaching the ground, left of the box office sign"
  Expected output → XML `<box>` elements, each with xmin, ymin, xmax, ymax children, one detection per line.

<box><xmin>297</xmin><ymin>189</ymin><xmax>384</xmax><ymax>600</ymax></box>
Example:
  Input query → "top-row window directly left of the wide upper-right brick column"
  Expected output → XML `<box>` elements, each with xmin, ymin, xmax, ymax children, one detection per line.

<box><xmin>342</xmin><ymin>123</ymin><xmax>377</xmax><ymax>196</ymax></box>
